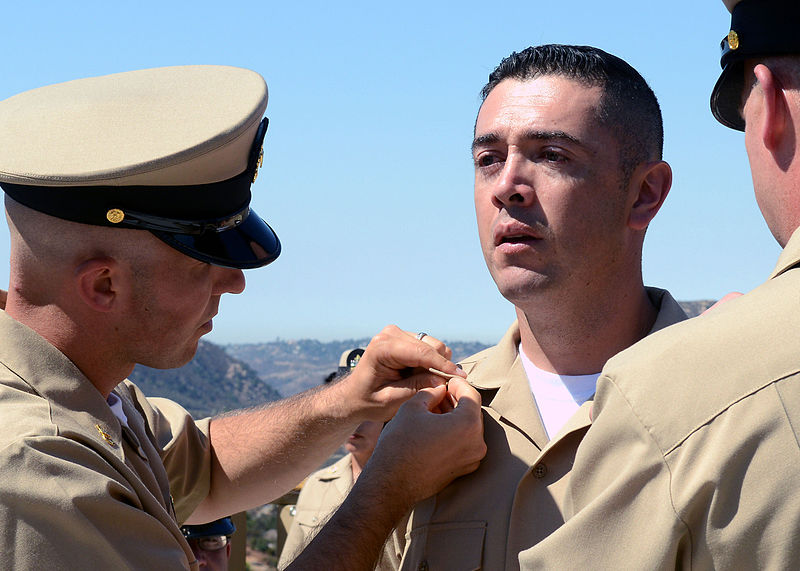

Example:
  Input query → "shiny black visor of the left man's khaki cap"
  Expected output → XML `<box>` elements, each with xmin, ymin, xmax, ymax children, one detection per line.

<box><xmin>152</xmin><ymin>210</ymin><xmax>281</xmax><ymax>270</ymax></box>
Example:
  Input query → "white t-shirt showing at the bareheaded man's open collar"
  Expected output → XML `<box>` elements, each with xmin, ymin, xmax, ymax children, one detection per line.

<box><xmin>518</xmin><ymin>345</ymin><xmax>600</xmax><ymax>438</ymax></box>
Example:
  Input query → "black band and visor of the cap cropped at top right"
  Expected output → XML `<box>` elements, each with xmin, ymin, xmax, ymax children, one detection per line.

<box><xmin>711</xmin><ymin>0</ymin><xmax>800</xmax><ymax>131</ymax></box>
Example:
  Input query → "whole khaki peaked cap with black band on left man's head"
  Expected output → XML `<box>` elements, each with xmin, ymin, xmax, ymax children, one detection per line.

<box><xmin>0</xmin><ymin>65</ymin><xmax>280</xmax><ymax>268</ymax></box>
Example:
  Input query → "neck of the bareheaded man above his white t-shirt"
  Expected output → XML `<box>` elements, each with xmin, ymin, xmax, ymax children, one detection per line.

<box><xmin>516</xmin><ymin>281</ymin><xmax>658</xmax><ymax>375</ymax></box>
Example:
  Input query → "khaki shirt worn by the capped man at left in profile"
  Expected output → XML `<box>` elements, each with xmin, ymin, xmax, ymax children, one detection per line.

<box><xmin>0</xmin><ymin>311</ymin><xmax>210</xmax><ymax>570</ymax></box>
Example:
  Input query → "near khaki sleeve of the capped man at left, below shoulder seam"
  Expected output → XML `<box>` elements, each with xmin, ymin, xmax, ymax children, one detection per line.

<box><xmin>0</xmin><ymin>436</ymin><xmax>190</xmax><ymax>570</ymax></box>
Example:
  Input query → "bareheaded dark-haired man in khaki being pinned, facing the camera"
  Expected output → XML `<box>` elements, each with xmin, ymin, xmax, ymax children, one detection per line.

<box><xmin>394</xmin><ymin>45</ymin><xmax>685</xmax><ymax>571</ymax></box>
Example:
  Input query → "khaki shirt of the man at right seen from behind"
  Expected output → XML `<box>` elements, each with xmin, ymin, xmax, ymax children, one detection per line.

<box><xmin>519</xmin><ymin>232</ymin><xmax>800</xmax><ymax>570</ymax></box>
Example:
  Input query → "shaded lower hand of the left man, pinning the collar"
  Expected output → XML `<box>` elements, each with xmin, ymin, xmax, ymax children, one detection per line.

<box><xmin>367</xmin><ymin>378</ymin><xmax>486</xmax><ymax>508</ymax></box>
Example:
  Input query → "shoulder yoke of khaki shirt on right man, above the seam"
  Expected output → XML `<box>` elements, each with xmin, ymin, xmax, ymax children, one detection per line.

<box><xmin>594</xmin><ymin>272</ymin><xmax>800</xmax><ymax>448</ymax></box>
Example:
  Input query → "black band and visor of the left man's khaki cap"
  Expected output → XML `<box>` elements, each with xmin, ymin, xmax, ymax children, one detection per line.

<box><xmin>0</xmin><ymin>118</ymin><xmax>281</xmax><ymax>269</ymax></box>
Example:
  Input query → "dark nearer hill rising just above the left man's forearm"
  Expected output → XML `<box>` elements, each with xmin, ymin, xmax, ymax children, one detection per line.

<box><xmin>130</xmin><ymin>341</ymin><xmax>281</xmax><ymax>418</ymax></box>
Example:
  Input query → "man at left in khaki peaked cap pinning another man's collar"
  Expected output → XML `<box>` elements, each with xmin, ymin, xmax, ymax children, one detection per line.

<box><xmin>0</xmin><ymin>66</ymin><xmax>484</xmax><ymax>569</ymax></box>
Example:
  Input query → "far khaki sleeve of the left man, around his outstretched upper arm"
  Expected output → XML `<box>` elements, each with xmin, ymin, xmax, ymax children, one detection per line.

<box><xmin>129</xmin><ymin>384</ymin><xmax>211</xmax><ymax>523</ymax></box>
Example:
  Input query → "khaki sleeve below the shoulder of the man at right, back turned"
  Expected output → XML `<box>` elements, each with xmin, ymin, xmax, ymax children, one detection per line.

<box><xmin>519</xmin><ymin>374</ymin><xmax>691</xmax><ymax>570</ymax></box>
